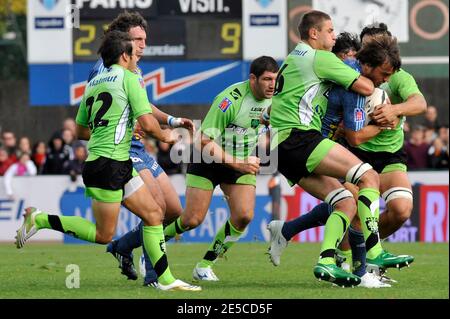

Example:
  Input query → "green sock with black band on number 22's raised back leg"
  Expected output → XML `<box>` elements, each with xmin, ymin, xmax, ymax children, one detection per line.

<box><xmin>35</xmin><ymin>213</ymin><xmax>96</xmax><ymax>243</ymax></box>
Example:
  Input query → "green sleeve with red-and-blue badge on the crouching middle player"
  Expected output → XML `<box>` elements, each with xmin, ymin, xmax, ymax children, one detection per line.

<box><xmin>200</xmin><ymin>93</ymin><xmax>236</xmax><ymax>139</ymax></box>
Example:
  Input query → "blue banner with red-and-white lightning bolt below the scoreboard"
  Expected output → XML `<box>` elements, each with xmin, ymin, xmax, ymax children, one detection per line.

<box><xmin>30</xmin><ymin>60</ymin><xmax>249</xmax><ymax>106</ymax></box>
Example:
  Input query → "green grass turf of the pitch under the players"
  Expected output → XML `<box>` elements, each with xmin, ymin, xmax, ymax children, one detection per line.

<box><xmin>0</xmin><ymin>243</ymin><xmax>449</xmax><ymax>299</ymax></box>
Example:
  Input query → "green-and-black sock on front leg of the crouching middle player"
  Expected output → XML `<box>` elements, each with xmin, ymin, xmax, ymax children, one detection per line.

<box><xmin>199</xmin><ymin>220</ymin><xmax>243</xmax><ymax>267</ymax></box>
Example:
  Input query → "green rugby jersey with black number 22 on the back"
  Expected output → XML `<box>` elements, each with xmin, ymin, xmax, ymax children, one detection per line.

<box><xmin>76</xmin><ymin>64</ymin><xmax>152</xmax><ymax>161</ymax></box>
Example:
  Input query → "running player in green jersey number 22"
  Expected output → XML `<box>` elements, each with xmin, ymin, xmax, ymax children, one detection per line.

<box><xmin>16</xmin><ymin>31</ymin><xmax>201</xmax><ymax>291</ymax></box>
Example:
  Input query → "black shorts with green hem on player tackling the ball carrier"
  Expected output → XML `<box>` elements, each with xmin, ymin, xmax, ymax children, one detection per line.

<box><xmin>278</xmin><ymin>128</ymin><xmax>335</xmax><ymax>186</ymax></box>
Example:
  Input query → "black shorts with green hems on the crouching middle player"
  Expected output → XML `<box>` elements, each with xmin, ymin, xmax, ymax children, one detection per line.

<box><xmin>186</xmin><ymin>162</ymin><xmax>256</xmax><ymax>190</ymax></box>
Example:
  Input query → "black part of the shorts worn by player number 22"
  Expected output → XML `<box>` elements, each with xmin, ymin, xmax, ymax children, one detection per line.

<box><xmin>82</xmin><ymin>156</ymin><xmax>133</xmax><ymax>191</ymax></box>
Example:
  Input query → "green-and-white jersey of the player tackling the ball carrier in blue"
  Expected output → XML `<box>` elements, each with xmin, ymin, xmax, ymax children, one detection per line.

<box><xmin>270</xmin><ymin>42</ymin><xmax>360</xmax><ymax>143</ymax></box>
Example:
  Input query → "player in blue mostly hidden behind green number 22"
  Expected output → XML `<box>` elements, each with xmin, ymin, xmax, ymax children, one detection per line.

<box><xmin>96</xmin><ymin>11</ymin><xmax>194</xmax><ymax>288</ymax></box>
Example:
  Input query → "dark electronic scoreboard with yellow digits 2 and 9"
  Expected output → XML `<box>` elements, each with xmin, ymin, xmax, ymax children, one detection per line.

<box><xmin>73</xmin><ymin>0</ymin><xmax>242</xmax><ymax>61</ymax></box>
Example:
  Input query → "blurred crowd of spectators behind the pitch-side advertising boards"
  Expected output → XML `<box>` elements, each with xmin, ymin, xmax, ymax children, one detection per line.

<box><xmin>0</xmin><ymin>106</ymin><xmax>449</xmax><ymax>196</ymax></box>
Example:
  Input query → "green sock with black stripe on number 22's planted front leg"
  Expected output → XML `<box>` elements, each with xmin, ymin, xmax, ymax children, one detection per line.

<box><xmin>142</xmin><ymin>225</ymin><xmax>175</xmax><ymax>285</ymax></box>
